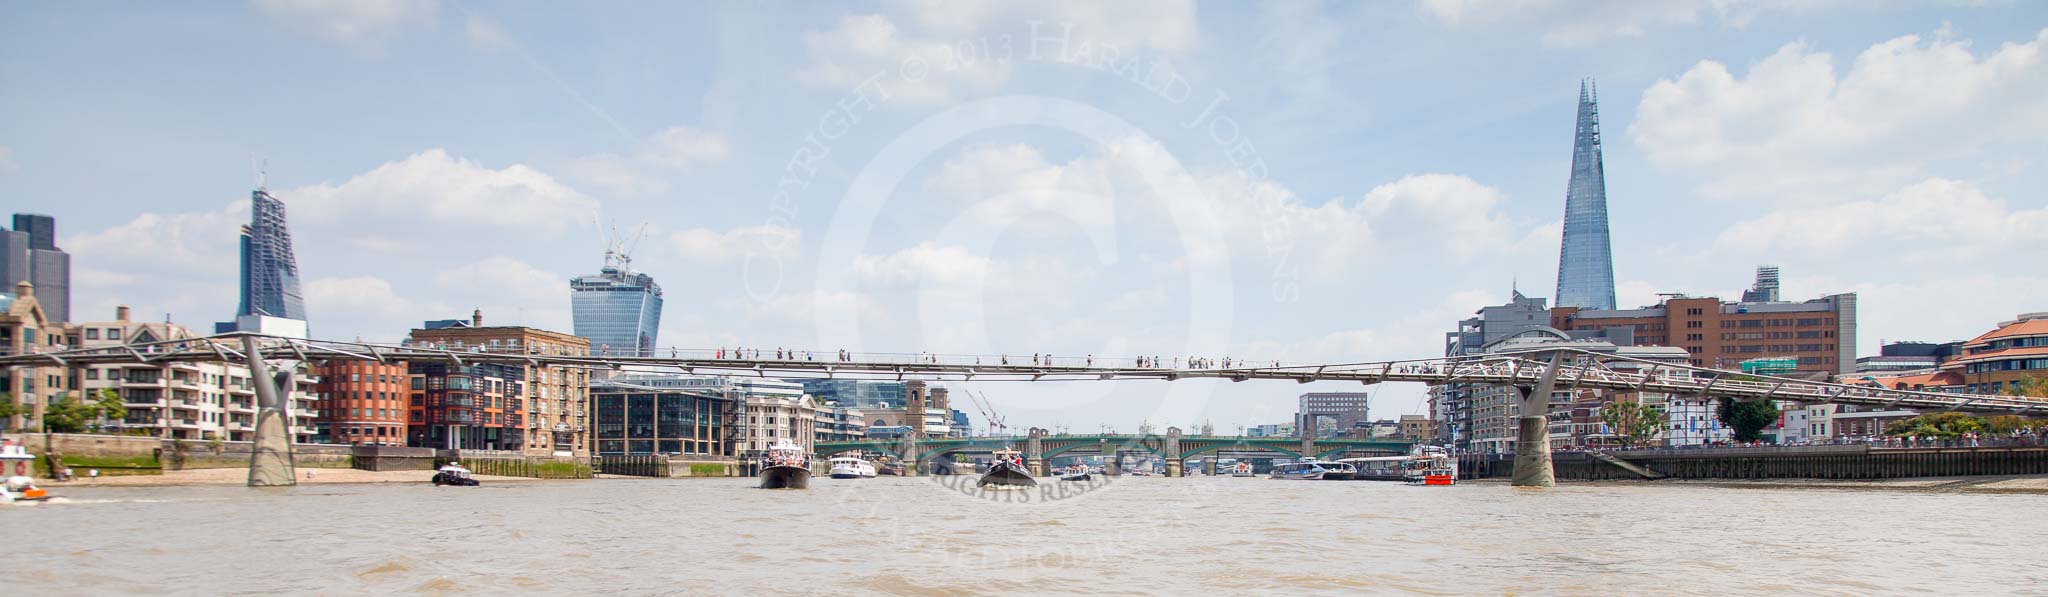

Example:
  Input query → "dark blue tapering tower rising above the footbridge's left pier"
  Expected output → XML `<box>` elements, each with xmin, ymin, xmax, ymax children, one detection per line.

<box><xmin>236</xmin><ymin>188</ymin><xmax>305</xmax><ymax>321</ymax></box>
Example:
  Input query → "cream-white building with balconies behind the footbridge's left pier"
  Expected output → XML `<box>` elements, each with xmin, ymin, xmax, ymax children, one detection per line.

<box><xmin>72</xmin><ymin>307</ymin><xmax>317</xmax><ymax>444</ymax></box>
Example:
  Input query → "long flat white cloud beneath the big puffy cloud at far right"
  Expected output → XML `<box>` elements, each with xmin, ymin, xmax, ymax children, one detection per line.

<box><xmin>1718</xmin><ymin>178</ymin><xmax>2048</xmax><ymax>260</ymax></box>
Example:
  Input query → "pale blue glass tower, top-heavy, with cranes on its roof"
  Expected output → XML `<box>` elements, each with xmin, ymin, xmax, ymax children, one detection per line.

<box><xmin>569</xmin><ymin>256</ymin><xmax>662</xmax><ymax>356</ymax></box>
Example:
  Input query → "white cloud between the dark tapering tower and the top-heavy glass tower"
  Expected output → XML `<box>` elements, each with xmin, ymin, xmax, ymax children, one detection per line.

<box><xmin>276</xmin><ymin>149</ymin><xmax>598</xmax><ymax>231</ymax></box>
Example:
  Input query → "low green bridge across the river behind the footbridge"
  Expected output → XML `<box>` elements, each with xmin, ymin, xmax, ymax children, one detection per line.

<box><xmin>815</xmin><ymin>427</ymin><xmax>1415</xmax><ymax>476</ymax></box>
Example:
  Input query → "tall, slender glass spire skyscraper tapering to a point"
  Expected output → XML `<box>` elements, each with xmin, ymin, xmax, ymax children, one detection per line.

<box><xmin>1556</xmin><ymin>80</ymin><xmax>1614</xmax><ymax>309</ymax></box>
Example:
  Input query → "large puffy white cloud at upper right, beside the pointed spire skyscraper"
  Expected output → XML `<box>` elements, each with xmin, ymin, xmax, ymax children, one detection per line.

<box><xmin>1628</xmin><ymin>29</ymin><xmax>2048</xmax><ymax>200</ymax></box>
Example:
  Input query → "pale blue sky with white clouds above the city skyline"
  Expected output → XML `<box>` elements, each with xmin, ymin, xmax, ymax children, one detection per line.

<box><xmin>0</xmin><ymin>0</ymin><xmax>2048</xmax><ymax>433</ymax></box>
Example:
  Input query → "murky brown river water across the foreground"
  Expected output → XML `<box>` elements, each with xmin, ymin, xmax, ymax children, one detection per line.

<box><xmin>16</xmin><ymin>476</ymin><xmax>2048</xmax><ymax>595</ymax></box>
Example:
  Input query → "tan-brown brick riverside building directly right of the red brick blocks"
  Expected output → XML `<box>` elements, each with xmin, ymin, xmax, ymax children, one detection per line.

<box><xmin>406</xmin><ymin>313</ymin><xmax>590</xmax><ymax>458</ymax></box>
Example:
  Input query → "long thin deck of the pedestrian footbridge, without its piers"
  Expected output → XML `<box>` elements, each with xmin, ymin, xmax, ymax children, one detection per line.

<box><xmin>0</xmin><ymin>333</ymin><xmax>2048</xmax><ymax>413</ymax></box>
